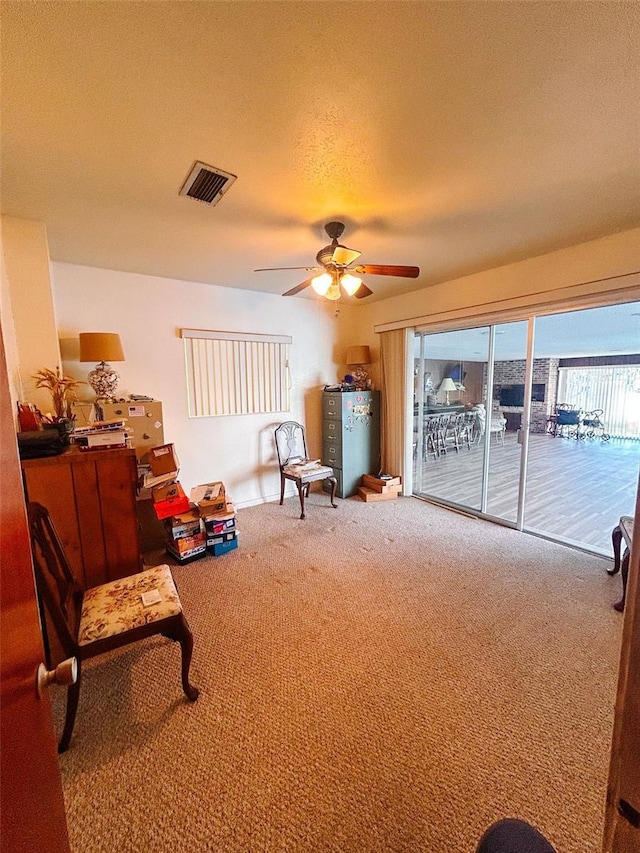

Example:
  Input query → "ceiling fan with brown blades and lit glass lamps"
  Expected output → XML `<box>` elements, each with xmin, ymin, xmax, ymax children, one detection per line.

<box><xmin>254</xmin><ymin>222</ymin><xmax>420</xmax><ymax>300</ymax></box>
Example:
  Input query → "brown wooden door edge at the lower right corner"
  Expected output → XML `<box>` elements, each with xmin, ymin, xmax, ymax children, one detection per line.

<box><xmin>602</xmin><ymin>472</ymin><xmax>640</xmax><ymax>853</ymax></box>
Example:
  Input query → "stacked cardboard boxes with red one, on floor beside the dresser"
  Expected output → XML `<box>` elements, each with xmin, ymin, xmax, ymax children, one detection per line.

<box><xmin>143</xmin><ymin>444</ymin><xmax>238</xmax><ymax>563</ymax></box>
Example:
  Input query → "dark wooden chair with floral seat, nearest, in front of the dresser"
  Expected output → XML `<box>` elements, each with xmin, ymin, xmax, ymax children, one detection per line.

<box><xmin>27</xmin><ymin>503</ymin><xmax>199</xmax><ymax>752</ymax></box>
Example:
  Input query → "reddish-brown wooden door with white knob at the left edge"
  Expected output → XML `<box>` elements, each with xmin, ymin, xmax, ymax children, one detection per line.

<box><xmin>0</xmin><ymin>329</ymin><xmax>69</xmax><ymax>853</ymax></box>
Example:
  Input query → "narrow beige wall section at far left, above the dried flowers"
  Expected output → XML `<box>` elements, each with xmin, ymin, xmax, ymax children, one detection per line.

<box><xmin>2</xmin><ymin>216</ymin><xmax>60</xmax><ymax>412</ymax></box>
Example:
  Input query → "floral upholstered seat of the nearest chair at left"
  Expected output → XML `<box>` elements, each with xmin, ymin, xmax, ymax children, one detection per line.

<box><xmin>78</xmin><ymin>566</ymin><xmax>182</xmax><ymax>646</ymax></box>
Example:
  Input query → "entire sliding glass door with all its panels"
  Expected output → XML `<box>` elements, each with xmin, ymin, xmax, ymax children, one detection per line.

<box><xmin>413</xmin><ymin>303</ymin><xmax>640</xmax><ymax>554</ymax></box>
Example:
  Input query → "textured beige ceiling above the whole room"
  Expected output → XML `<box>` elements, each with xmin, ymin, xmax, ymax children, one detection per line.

<box><xmin>0</xmin><ymin>0</ymin><xmax>640</xmax><ymax>299</ymax></box>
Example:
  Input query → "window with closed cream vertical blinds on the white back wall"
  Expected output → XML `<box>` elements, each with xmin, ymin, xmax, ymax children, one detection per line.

<box><xmin>180</xmin><ymin>329</ymin><xmax>292</xmax><ymax>418</ymax></box>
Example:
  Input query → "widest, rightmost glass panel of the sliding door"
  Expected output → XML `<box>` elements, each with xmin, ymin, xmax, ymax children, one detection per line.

<box><xmin>524</xmin><ymin>302</ymin><xmax>640</xmax><ymax>555</ymax></box>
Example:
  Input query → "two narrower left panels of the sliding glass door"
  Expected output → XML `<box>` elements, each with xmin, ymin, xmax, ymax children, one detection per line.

<box><xmin>414</xmin><ymin>322</ymin><xmax>527</xmax><ymax>522</ymax></box>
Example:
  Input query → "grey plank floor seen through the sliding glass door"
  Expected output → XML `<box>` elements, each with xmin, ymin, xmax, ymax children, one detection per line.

<box><xmin>414</xmin><ymin>432</ymin><xmax>640</xmax><ymax>555</ymax></box>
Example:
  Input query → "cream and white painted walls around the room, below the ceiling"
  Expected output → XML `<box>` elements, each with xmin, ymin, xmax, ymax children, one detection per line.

<box><xmin>2</xmin><ymin>218</ymin><xmax>640</xmax><ymax>506</ymax></box>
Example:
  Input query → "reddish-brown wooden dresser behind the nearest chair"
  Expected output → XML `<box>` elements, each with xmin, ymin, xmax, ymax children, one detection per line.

<box><xmin>22</xmin><ymin>446</ymin><xmax>142</xmax><ymax>588</ymax></box>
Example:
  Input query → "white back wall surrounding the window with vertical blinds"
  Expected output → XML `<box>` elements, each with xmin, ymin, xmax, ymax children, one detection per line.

<box><xmin>52</xmin><ymin>263</ymin><xmax>359</xmax><ymax>506</ymax></box>
